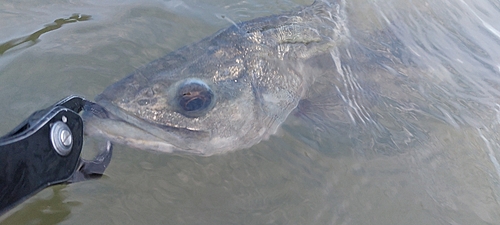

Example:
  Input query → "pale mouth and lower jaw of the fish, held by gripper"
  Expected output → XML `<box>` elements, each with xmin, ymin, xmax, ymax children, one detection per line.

<box><xmin>82</xmin><ymin>101</ymin><xmax>208</xmax><ymax>155</ymax></box>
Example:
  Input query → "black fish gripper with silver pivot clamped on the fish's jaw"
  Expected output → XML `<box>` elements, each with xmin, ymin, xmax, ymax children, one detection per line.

<box><xmin>0</xmin><ymin>96</ymin><xmax>112</xmax><ymax>215</ymax></box>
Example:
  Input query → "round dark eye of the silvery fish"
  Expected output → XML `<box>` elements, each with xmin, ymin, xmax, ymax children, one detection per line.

<box><xmin>177</xmin><ymin>80</ymin><xmax>214</xmax><ymax>117</ymax></box>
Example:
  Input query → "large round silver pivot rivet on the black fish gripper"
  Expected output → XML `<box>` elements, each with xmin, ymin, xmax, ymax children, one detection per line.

<box><xmin>50</xmin><ymin>121</ymin><xmax>73</xmax><ymax>156</ymax></box>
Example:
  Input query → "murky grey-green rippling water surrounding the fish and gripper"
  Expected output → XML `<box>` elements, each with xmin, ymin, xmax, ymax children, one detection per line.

<box><xmin>0</xmin><ymin>0</ymin><xmax>500</xmax><ymax>224</ymax></box>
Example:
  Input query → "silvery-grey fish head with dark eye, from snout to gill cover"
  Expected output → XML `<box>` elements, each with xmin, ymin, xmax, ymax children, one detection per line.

<box><xmin>84</xmin><ymin>28</ymin><xmax>304</xmax><ymax>155</ymax></box>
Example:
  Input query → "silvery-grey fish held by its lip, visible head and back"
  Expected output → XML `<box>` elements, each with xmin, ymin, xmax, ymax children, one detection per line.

<box><xmin>83</xmin><ymin>1</ymin><xmax>348</xmax><ymax>156</ymax></box>
